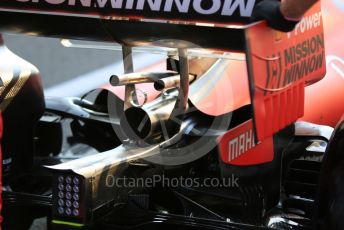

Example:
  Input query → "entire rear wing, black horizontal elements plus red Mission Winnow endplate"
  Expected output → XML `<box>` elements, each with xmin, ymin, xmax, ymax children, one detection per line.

<box><xmin>0</xmin><ymin>0</ymin><xmax>326</xmax><ymax>141</ymax></box>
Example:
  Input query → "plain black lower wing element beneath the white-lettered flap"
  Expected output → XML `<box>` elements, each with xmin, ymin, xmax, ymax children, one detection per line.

<box><xmin>0</xmin><ymin>11</ymin><xmax>245</xmax><ymax>51</ymax></box>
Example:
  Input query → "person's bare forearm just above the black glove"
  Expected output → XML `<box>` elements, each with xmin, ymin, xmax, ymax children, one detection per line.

<box><xmin>280</xmin><ymin>0</ymin><xmax>318</xmax><ymax>21</ymax></box>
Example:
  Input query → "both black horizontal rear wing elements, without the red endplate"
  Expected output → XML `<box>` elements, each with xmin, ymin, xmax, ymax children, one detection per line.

<box><xmin>0</xmin><ymin>0</ymin><xmax>258</xmax><ymax>51</ymax></box>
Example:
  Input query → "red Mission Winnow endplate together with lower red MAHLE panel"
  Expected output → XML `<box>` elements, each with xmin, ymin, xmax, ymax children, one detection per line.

<box><xmin>218</xmin><ymin>2</ymin><xmax>326</xmax><ymax>166</ymax></box>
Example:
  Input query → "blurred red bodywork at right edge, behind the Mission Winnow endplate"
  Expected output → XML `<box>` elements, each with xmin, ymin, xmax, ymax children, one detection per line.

<box><xmin>301</xmin><ymin>0</ymin><xmax>344</xmax><ymax>127</ymax></box>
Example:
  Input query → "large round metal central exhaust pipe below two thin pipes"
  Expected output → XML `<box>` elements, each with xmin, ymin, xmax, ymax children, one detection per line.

<box><xmin>120</xmin><ymin>90</ymin><xmax>180</xmax><ymax>141</ymax></box>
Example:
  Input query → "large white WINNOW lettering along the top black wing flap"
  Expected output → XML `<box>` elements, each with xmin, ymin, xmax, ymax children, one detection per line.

<box><xmin>14</xmin><ymin>0</ymin><xmax>256</xmax><ymax>17</ymax></box>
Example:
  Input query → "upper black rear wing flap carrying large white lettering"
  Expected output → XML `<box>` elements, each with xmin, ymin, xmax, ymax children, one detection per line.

<box><xmin>1</xmin><ymin>0</ymin><xmax>259</xmax><ymax>24</ymax></box>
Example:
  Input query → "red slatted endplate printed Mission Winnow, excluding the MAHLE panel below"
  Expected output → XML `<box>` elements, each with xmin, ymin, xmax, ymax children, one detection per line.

<box><xmin>246</xmin><ymin>2</ymin><xmax>326</xmax><ymax>142</ymax></box>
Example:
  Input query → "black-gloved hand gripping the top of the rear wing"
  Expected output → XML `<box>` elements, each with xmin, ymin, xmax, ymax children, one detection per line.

<box><xmin>251</xmin><ymin>0</ymin><xmax>302</xmax><ymax>32</ymax></box>
